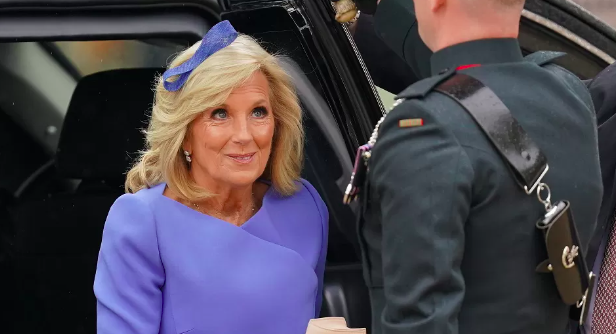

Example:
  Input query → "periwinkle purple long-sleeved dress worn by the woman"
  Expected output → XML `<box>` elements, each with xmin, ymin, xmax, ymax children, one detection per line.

<box><xmin>94</xmin><ymin>180</ymin><xmax>328</xmax><ymax>334</ymax></box>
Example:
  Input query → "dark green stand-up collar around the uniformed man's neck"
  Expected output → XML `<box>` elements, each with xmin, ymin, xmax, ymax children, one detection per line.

<box><xmin>430</xmin><ymin>38</ymin><xmax>524</xmax><ymax>75</ymax></box>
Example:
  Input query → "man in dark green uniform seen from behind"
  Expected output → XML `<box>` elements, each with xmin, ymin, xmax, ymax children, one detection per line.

<box><xmin>359</xmin><ymin>0</ymin><xmax>602</xmax><ymax>334</ymax></box>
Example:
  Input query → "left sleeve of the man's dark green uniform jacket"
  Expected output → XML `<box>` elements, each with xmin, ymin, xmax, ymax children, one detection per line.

<box><xmin>367</xmin><ymin>101</ymin><xmax>474</xmax><ymax>334</ymax></box>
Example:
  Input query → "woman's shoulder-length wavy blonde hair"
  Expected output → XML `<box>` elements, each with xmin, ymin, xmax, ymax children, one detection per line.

<box><xmin>125</xmin><ymin>34</ymin><xmax>304</xmax><ymax>201</ymax></box>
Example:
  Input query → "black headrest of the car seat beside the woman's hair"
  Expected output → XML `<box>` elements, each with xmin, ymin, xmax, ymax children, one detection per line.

<box><xmin>56</xmin><ymin>68</ymin><xmax>163</xmax><ymax>179</ymax></box>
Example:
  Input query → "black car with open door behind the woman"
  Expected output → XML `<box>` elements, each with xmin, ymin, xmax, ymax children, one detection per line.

<box><xmin>0</xmin><ymin>0</ymin><xmax>616</xmax><ymax>334</ymax></box>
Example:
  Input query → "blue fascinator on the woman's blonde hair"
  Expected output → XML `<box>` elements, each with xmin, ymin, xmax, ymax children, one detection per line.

<box><xmin>163</xmin><ymin>20</ymin><xmax>238</xmax><ymax>92</ymax></box>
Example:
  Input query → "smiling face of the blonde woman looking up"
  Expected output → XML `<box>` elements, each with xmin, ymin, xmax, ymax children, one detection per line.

<box><xmin>184</xmin><ymin>71</ymin><xmax>274</xmax><ymax>191</ymax></box>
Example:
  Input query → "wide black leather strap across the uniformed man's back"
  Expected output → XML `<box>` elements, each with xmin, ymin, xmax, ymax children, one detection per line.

<box><xmin>435</xmin><ymin>73</ymin><xmax>548</xmax><ymax>194</ymax></box>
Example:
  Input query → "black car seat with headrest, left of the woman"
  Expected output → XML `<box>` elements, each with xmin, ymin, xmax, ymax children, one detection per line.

<box><xmin>14</xmin><ymin>69</ymin><xmax>158</xmax><ymax>334</ymax></box>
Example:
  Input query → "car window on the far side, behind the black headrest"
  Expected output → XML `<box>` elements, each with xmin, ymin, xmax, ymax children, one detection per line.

<box><xmin>0</xmin><ymin>40</ymin><xmax>186</xmax><ymax>193</ymax></box>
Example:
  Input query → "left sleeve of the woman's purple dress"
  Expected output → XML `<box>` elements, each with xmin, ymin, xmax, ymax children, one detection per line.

<box><xmin>94</xmin><ymin>195</ymin><xmax>165</xmax><ymax>334</ymax></box>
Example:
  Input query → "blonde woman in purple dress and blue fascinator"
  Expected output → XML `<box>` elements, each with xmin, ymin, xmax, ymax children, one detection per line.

<box><xmin>94</xmin><ymin>21</ymin><xmax>328</xmax><ymax>334</ymax></box>
